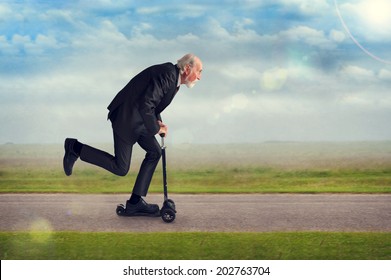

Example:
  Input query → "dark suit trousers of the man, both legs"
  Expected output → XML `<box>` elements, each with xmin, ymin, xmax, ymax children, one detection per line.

<box><xmin>80</xmin><ymin>131</ymin><xmax>162</xmax><ymax>196</ymax></box>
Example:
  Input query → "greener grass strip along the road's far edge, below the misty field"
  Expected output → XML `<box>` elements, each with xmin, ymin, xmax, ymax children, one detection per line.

<box><xmin>0</xmin><ymin>167</ymin><xmax>391</xmax><ymax>193</ymax></box>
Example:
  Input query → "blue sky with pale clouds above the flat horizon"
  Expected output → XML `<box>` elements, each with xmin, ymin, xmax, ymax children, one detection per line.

<box><xmin>0</xmin><ymin>0</ymin><xmax>391</xmax><ymax>144</ymax></box>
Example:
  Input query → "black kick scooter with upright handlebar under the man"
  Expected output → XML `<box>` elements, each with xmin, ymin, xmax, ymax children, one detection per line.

<box><xmin>116</xmin><ymin>133</ymin><xmax>176</xmax><ymax>223</ymax></box>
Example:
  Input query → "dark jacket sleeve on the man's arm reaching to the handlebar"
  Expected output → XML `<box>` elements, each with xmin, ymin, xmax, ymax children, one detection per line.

<box><xmin>138</xmin><ymin>75</ymin><xmax>165</xmax><ymax>135</ymax></box>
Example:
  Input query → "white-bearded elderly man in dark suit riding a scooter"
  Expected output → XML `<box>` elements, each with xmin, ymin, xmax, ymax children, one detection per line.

<box><xmin>63</xmin><ymin>54</ymin><xmax>202</xmax><ymax>216</ymax></box>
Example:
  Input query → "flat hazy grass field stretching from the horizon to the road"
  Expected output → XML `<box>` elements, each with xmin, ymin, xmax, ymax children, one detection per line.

<box><xmin>0</xmin><ymin>141</ymin><xmax>391</xmax><ymax>193</ymax></box>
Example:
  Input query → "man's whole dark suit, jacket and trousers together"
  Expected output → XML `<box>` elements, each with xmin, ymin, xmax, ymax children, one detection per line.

<box><xmin>80</xmin><ymin>63</ymin><xmax>179</xmax><ymax>196</ymax></box>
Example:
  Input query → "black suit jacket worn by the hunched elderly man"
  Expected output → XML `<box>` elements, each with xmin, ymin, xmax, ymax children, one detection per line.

<box><xmin>107</xmin><ymin>62</ymin><xmax>179</xmax><ymax>143</ymax></box>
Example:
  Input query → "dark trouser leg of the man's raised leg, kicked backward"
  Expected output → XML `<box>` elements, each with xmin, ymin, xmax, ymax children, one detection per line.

<box><xmin>80</xmin><ymin>133</ymin><xmax>133</xmax><ymax>176</ymax></box>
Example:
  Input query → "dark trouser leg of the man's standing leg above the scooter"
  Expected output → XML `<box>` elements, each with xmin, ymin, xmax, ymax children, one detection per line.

<box><xmin>133</xmin><ymin>136</ymin><xmax>162</xmax><ymax>196</ymax></box>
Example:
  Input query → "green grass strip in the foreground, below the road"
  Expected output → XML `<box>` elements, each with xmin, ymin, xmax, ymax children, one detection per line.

<box><xmin>0</xmin><ymin>232</ymin><xmax>391</xmax><ymax>260</ymax></box>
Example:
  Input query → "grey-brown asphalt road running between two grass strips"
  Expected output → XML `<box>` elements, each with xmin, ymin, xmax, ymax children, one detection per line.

<box><xmin>0</xmin><ymin>194</ymin><xmax>391</xmax><ymax>232</ymax></box>
